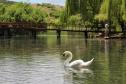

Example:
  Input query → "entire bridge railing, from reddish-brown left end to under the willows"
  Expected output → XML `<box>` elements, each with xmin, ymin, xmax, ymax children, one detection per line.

<box><xmin>0</xmin><ymin>22</ymin><xmax>122</xmax><ymax>33</ymax></box>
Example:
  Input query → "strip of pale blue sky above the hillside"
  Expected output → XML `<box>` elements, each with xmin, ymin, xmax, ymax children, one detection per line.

<box><xmin>9</xmin><ymin>0</ymin><xmax>65</xmax><ymax>6</ymax></box>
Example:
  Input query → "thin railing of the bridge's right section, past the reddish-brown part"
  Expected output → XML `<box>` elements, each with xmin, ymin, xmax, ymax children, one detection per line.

<box><xmin>47</xmin><ymin>24</ymin><xmax>123</xmax><ymax>33</ymax></box>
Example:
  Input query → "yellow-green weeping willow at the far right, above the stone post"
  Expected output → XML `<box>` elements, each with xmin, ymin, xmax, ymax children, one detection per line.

<box><xmin>95</xmin><ymin>0</ymin><xmax>126</xmax><ymax>30</ymax></box>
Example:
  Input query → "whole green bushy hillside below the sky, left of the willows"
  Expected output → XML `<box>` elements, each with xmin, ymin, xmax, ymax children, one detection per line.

<box><xmin>0</xmin><ymin>0</ymin><xmax>64</xmax><ymax>23</ymax></box>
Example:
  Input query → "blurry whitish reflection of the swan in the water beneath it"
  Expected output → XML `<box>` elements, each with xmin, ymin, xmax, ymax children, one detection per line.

<box><xmin>64</xmin><ymin>67</ymin><xmax>94</xmax><ymax>84</ymax></box>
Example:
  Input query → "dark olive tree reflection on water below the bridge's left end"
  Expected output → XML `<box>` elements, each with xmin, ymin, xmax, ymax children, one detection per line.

<box><xmin>0</xmin><ymin>38</ymin><xmax>46</xmax><ymax>57</ymax></box>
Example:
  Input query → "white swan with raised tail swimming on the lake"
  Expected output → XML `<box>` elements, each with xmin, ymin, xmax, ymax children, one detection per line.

<box><xmin>63</xmin><ymin>51</ymin><xmax>94</xmax><ymax>68</ymax></box>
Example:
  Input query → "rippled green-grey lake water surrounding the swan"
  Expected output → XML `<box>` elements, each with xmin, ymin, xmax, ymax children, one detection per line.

<box><xmin>0</xmin><ymin>31</ymin><xmax>126</xmax><ymax>84</ymax></box>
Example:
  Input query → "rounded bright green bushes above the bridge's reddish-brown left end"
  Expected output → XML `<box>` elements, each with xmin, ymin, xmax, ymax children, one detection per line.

<box><xmin>0</xmin><ymin>3</ymin><xmax>45</xmax><ymax>22</ymax></box>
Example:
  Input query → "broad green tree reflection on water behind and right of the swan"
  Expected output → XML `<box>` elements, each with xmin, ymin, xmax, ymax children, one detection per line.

<box><xmin>61</xmin><ymin>39</ymin><xmax>126</xmax><ymax>84</ymax></box>
